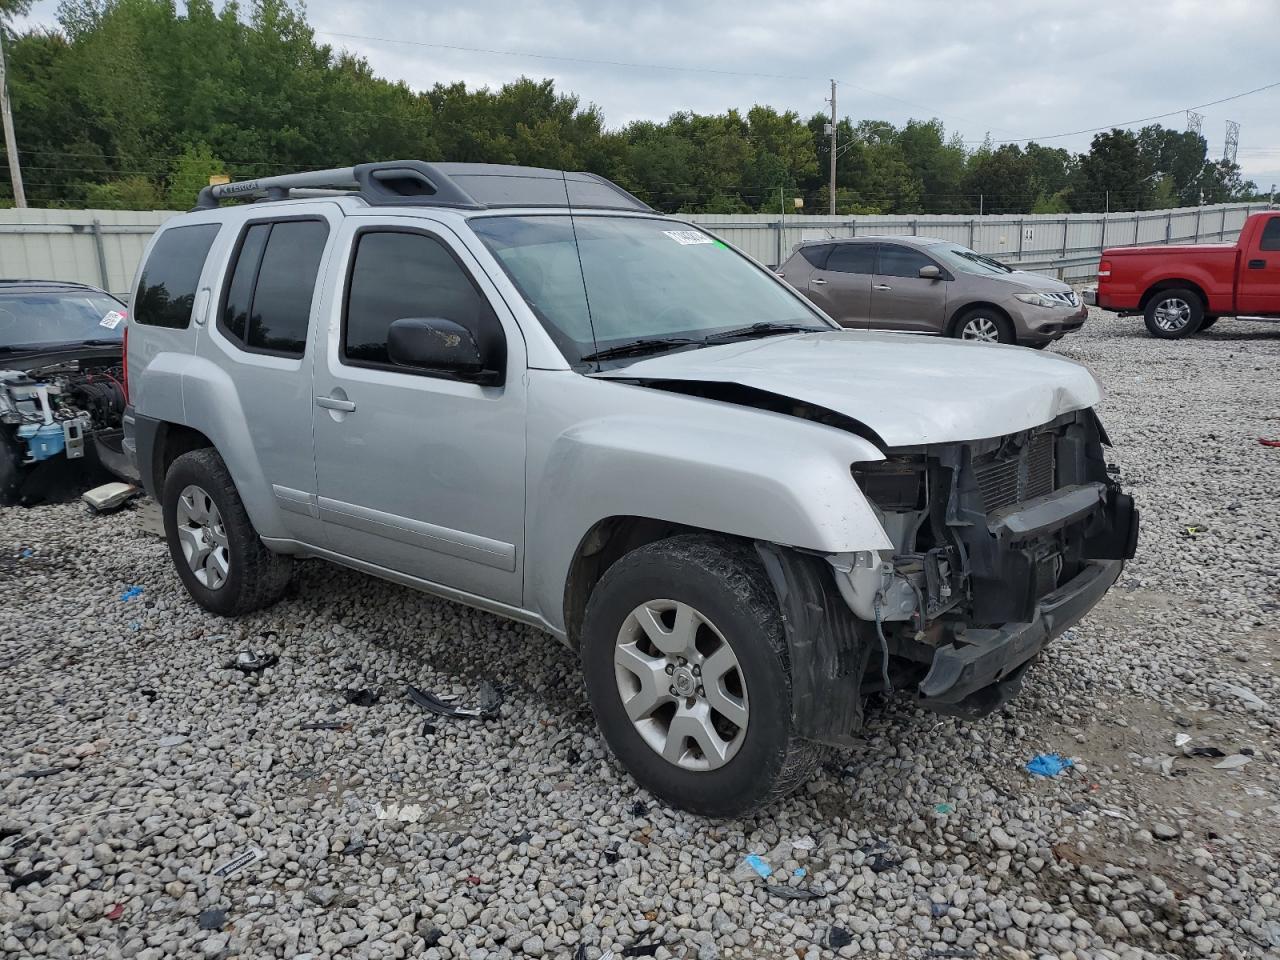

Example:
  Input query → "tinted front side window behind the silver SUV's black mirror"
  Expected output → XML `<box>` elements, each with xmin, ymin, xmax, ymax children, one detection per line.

<box><xmin>342</xmin><ymin>230</ymin><xmax>503</xmax><ymax>364</ymax></box>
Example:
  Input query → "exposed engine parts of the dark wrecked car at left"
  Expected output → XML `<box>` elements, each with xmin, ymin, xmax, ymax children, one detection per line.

<box><xmin>0</xmin><ymin>358</ymin><xmax>124</xmax><ymax>465</ymax></box>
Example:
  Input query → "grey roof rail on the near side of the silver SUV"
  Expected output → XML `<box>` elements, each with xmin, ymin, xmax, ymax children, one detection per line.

<box><xmin>196</xmin><ymin>160</ymin><xmax>484</xmax><ymax>210</ymax></box>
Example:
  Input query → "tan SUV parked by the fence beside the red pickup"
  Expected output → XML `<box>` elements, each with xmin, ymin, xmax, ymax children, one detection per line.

<box><xmin>778</xmin><ymin>237</ymin><xmax>1088</xmax><ymax>347</ymax></box>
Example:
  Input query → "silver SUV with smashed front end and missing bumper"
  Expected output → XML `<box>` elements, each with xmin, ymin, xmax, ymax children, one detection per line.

<box><xmin>127</xmin><ymin>161</ymin><xmax>1138</xmax><ymax>815</ymax></box>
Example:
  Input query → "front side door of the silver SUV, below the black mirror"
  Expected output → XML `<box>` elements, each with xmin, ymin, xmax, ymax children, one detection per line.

<box><xmin>314</xmin><ymin>216</ymin><xmax>526</xmax><ymax>605</ymax></box>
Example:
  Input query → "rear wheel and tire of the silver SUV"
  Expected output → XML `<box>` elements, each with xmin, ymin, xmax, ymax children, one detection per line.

<box><xmin>161</xmin><ymin>447</ymin><xmax>293</xmax><ymax>617</ymax></box>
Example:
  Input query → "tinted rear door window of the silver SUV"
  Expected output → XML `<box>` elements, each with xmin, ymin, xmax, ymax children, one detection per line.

<box><xmin>219</xmin><ymin>220</ymin><xmax>329</xmax><ymax>357</ymax></box>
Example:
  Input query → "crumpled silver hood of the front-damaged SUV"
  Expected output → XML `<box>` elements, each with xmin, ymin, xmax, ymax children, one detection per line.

<box><xmin>593</xmin><ymin>330</ymin><xmax>1102</xmax><ymax>447</ymax></box>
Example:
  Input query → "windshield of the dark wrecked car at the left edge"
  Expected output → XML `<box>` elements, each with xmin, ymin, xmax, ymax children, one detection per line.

<box><xmin>0</xmin><ymin>291</ymin><xmax>125</xmax><ymax>358</ymax></box>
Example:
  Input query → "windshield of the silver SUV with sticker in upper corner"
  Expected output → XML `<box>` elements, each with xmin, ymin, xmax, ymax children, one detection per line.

<box><xmin>470</xmin><ymin>215</ymin><xmax>831</xmax><ymax>364</ymax></box>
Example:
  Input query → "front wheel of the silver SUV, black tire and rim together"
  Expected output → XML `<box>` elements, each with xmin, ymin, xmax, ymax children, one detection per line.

<box><xmin>581</xmin><ymin>535</ymin><xmax>820</xmax><ymax>817</ymax></box>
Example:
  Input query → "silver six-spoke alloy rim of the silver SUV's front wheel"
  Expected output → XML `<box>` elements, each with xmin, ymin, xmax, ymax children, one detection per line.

<box><xmin>613</xmin><ymin>600</ymin><xmax>750</xmax><ymax>771</ymax></box>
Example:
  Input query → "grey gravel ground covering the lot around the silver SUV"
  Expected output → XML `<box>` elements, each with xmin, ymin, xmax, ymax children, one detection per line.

<box><xmin>0</xmin><ymin>315</ymin><xmax>1280</xmax><ymax>960</ymax></box>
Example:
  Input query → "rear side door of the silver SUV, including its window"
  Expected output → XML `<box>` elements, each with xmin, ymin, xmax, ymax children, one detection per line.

<box><xmin>197</xmin><ymin>204</ymin><xmax>340</xmax><ymax>544</ymax></box>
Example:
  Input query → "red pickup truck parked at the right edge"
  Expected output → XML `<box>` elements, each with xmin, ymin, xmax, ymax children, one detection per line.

<box><xmin>1084</xmin><ymin>210</ymin><xmax>1280</xmax><ymax>340</ymax></box>
